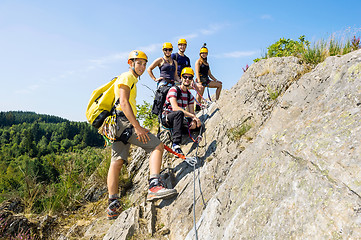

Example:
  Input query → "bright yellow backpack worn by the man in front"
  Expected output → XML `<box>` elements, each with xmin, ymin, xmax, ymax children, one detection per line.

<box><xmin>85</xmin><ymin>77</ymin><xmax>118</xmax><ymax>128</ymax></box>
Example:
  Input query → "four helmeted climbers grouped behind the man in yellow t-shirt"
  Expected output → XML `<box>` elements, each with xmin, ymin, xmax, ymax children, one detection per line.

<box><xmin>147</xmin><ymin>39</ymin><xmax>222</xmax><ymax>154</ymax></box>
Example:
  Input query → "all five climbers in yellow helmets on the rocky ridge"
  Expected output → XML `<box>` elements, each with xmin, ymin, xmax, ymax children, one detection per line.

<box><xmin>107</xmin><ymin>39</ymin><xmax>222</xmax><ymax>219</ymax></box>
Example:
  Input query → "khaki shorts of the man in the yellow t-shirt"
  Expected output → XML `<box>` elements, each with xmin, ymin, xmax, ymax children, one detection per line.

<box><xmin>111</xmin><ymin>113</ymin><xmax>161</xmax><ymax>163</ymax></box>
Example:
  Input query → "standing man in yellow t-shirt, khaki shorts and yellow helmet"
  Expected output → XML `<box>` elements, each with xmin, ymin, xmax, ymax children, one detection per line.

<box><xmin>107</xmin><ymin>50</ymin><xmax>177</xmax><ymax>219</ymax></box>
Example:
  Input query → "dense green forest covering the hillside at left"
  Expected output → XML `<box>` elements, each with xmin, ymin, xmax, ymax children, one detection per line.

<box><xmin>0</xmin><ymin>111</ymin><xmax>104</xmax><ymax>213</ymax></box>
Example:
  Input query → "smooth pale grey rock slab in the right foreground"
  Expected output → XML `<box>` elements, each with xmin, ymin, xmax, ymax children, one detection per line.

<box><xmin>187</xmin><ymin>51</ymin><xmax>361</xmax><ymax>239</ymax></box>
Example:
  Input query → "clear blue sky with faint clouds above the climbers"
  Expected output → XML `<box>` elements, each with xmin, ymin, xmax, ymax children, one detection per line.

<box><xmin>0</xmin><ymin>0</ymin><xmax>361</xmax><ymax>121</ymax></box>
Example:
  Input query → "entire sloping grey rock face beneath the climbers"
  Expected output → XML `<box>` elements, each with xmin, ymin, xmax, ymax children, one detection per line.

<box><xmin>103</xmin><ymin>50</ymin><xmax>361</xmax><ymax>239</ymax></box>
